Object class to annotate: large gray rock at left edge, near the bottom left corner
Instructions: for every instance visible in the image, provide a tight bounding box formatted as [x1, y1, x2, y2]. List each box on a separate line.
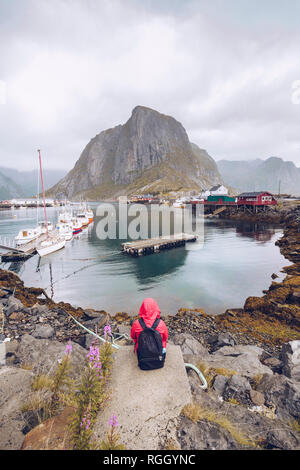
[0, 367, 32, 450]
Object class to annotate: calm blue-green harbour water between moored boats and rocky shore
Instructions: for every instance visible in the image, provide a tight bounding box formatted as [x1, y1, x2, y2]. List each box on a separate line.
[0, 205, 289, 314]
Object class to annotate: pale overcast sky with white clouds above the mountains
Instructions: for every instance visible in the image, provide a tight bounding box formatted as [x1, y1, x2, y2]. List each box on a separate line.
[0, 0, 300, 170]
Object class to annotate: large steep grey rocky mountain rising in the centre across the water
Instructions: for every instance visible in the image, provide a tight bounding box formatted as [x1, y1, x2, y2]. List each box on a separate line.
[47, 106, 222, 199]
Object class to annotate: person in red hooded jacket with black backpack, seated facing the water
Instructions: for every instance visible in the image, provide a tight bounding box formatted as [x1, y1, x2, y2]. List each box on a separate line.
[131, 298, 168, 370]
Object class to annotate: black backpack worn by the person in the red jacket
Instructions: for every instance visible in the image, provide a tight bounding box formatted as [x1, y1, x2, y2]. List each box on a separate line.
[137, 318, 165, 370]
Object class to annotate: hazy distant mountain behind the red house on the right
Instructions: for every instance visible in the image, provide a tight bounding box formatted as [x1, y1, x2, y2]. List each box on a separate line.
[217, 157, 300, 196]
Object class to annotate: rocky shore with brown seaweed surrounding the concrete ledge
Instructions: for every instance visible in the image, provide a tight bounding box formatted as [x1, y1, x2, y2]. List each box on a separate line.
[0, 206, 300, 449]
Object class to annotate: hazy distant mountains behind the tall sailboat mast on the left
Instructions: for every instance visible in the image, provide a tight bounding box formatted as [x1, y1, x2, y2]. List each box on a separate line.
[0, 167, 66, 200]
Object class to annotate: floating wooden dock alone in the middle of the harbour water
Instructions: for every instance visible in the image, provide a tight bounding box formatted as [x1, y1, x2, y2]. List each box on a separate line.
[121, 233, 197, 256]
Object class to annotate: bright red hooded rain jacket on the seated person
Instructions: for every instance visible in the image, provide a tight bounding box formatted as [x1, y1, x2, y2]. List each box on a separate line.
[130, 298, 168, 352]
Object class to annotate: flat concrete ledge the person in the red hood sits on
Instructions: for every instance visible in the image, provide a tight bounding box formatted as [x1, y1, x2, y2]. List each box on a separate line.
[95, 345, 192, 450]
